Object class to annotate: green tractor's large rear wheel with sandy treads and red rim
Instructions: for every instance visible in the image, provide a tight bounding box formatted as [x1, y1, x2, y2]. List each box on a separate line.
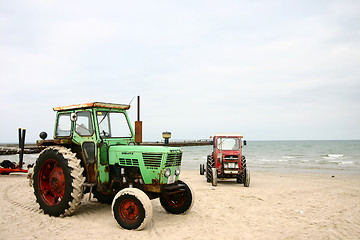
[33, 146, 85, 216]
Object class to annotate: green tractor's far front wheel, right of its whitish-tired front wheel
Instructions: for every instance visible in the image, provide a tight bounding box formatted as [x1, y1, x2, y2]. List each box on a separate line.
[160, 180, 195, 214]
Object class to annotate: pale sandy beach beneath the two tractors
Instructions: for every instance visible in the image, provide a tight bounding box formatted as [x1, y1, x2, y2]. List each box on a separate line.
[0, 170, 360, 240]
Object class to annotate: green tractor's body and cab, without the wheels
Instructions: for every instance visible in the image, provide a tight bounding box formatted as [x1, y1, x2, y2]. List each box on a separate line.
[38, 103, 182, 192]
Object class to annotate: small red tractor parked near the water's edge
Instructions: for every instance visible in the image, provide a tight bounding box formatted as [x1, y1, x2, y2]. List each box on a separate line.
[200, 133, 250, 187]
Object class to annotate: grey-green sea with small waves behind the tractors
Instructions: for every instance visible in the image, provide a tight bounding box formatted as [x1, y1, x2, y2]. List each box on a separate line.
[0, 140, 360, 175]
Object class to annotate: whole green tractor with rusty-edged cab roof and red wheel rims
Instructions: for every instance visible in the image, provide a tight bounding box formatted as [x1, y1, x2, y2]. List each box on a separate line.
[33, 99, 194, 230]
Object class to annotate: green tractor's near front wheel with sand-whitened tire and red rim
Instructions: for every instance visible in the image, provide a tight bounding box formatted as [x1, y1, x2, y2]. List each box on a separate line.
[111, 188, 153, 230]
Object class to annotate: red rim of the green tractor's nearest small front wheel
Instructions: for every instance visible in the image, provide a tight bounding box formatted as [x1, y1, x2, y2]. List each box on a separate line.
[118, 199, 140, 224]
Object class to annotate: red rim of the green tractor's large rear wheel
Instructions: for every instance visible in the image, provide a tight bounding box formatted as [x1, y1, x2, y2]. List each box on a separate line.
[38, 159, 65, 206]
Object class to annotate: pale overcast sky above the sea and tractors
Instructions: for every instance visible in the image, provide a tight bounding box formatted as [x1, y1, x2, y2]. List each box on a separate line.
[0, 0, 360, 143]
